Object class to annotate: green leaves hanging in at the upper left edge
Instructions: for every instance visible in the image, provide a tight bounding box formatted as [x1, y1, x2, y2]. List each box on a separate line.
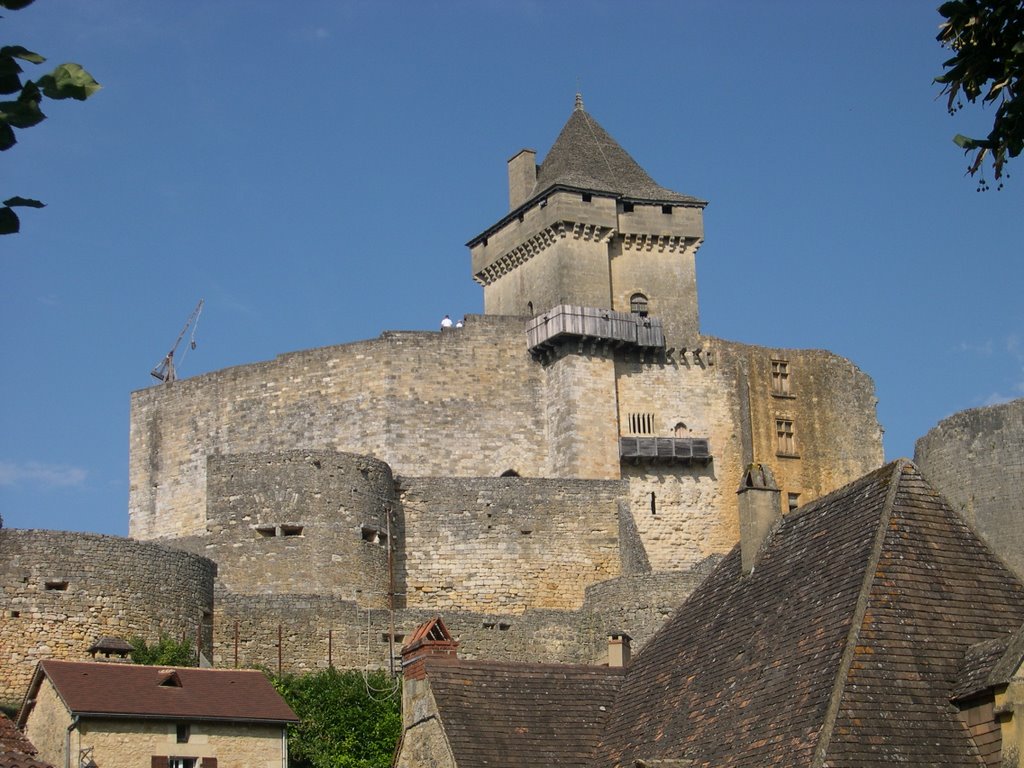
[0, 0, 99, 234]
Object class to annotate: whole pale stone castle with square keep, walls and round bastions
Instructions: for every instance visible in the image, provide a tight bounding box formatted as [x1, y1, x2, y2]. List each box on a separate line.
[0, 98, 883, 708]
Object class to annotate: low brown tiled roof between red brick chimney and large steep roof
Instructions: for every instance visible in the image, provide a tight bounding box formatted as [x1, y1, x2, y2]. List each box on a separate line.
[426, 659, 624, 768]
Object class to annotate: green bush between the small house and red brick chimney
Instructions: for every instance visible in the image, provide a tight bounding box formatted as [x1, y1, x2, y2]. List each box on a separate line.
[272, 669, 401, 768]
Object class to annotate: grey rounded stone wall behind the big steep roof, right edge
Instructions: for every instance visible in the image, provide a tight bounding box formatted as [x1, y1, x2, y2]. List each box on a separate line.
[913, 398, 1024, 578]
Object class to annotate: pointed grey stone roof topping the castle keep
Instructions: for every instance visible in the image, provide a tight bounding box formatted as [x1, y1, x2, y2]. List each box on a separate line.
[530, 96, 705, 205]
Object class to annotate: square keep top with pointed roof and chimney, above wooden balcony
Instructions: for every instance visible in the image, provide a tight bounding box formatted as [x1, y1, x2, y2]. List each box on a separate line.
[467, 95, 707, 347]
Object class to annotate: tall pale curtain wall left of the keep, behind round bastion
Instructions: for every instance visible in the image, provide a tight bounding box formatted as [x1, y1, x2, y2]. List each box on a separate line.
[129, 315, 548, 539]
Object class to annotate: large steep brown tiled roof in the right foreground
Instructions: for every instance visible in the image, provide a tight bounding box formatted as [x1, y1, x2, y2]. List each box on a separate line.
[596, 461, 1024, 768]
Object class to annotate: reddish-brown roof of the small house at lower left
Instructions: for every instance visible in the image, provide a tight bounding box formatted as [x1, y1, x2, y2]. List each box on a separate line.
[20, 659, 298, 724]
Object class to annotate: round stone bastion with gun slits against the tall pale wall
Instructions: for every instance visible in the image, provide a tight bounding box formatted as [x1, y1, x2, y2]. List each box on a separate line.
[184, 451, 398, 608]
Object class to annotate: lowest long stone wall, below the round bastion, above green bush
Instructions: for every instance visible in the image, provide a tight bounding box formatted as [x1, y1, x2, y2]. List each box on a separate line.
[215, 573, 711, 673]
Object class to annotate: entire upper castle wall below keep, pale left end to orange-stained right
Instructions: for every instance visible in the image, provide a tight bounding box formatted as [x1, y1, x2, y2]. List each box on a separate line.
[129, 315, 882, 573]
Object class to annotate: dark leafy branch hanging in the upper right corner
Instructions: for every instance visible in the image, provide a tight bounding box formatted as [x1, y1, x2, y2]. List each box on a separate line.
[935, 0, 1024, 189]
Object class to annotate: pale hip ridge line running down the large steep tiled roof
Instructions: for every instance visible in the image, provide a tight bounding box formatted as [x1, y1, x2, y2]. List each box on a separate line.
[811, 459, 916, 768]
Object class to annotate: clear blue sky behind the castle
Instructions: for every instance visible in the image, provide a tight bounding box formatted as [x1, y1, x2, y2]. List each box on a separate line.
[0, 0, 1024, 534]
